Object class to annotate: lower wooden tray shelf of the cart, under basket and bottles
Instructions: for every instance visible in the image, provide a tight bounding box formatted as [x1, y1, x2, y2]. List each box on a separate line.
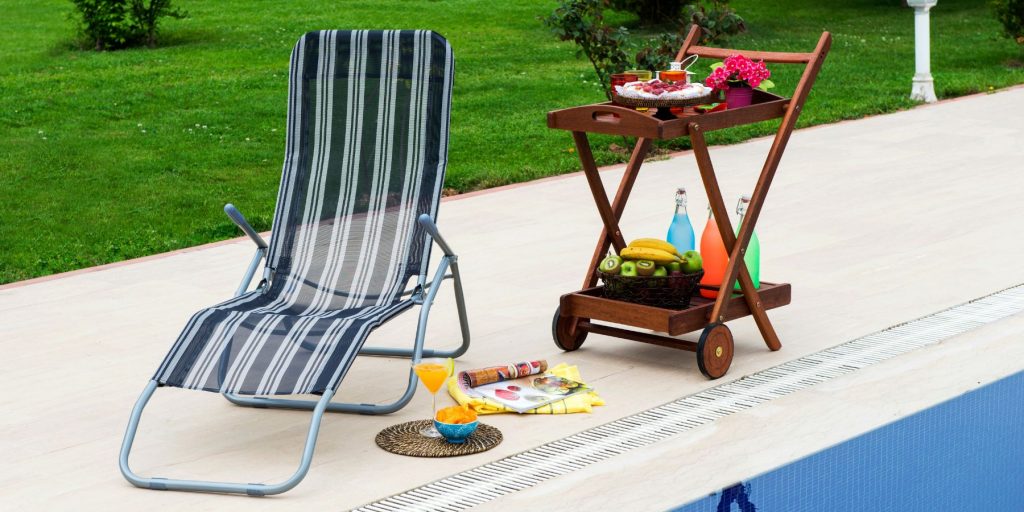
[559, 283, 791, 335]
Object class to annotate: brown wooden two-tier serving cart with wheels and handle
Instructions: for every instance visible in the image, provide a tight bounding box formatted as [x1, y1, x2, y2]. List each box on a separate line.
[548, 27, 831, 379]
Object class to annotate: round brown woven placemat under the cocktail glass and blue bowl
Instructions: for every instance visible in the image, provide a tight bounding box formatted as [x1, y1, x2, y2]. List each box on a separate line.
[376, 420, 502, 457]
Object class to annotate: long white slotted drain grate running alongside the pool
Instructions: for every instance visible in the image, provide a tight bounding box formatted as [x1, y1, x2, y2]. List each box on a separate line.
[356, 285, 1024, 511]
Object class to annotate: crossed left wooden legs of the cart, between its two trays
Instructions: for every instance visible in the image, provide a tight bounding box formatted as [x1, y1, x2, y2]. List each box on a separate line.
[572, 131, 651, 289]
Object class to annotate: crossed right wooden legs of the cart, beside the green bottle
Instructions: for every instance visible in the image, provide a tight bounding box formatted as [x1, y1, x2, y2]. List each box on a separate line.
[688, 123, 782, 350]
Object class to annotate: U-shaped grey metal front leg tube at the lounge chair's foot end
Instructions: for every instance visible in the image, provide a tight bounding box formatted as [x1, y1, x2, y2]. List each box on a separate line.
[119, 380, 334, 496]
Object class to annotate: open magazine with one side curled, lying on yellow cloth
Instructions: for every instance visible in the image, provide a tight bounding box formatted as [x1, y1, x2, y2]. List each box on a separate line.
[458, 361, 591, 413]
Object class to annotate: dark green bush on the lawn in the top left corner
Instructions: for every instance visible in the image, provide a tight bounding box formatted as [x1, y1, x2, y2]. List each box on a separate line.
[71, 0, 187, 51]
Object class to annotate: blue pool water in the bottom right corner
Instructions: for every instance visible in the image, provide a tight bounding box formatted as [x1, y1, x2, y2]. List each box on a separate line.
[675, 372, 1024, 512]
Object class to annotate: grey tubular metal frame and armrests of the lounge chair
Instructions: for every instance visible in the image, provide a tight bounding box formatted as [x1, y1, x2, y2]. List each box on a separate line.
[119, 204, 470, 496]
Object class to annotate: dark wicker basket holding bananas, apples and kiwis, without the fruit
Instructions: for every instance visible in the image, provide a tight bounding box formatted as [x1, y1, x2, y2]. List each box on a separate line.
[597, 270, 703, 309]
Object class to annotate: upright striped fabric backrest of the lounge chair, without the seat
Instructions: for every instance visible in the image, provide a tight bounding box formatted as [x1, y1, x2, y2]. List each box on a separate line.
[267, 31, 454, 313]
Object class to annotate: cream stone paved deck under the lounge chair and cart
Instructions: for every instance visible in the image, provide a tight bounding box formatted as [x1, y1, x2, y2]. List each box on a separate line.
[6, 88, 1024, 511]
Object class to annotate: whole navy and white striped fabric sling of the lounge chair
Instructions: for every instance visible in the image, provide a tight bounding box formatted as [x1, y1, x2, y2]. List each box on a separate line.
[155, 31, 454, 394]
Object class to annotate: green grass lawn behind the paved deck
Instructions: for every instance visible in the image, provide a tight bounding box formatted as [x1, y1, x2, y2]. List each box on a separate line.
[0, 0, 1024, 283]
